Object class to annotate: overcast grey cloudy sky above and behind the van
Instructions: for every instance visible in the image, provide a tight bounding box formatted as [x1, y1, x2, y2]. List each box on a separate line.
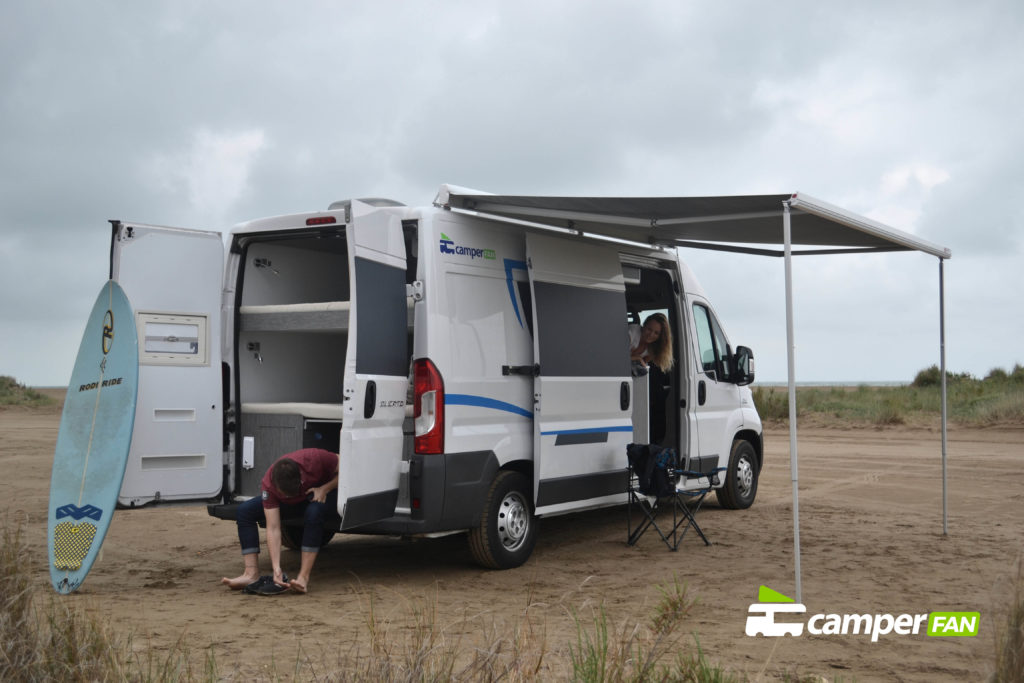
[0, 0, 1024, 385]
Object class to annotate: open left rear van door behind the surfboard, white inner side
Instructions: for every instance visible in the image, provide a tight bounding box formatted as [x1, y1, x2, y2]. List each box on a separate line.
[111, 221, 224, 506]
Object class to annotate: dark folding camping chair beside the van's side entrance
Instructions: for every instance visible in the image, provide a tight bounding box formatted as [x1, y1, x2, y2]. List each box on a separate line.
[626, 443, 725, 551]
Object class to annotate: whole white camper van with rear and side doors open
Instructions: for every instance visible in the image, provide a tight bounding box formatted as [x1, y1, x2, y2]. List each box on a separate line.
[111, 186, 764, 568]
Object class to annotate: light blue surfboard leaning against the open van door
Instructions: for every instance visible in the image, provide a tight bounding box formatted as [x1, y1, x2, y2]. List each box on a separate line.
[46, 280, 138, 594]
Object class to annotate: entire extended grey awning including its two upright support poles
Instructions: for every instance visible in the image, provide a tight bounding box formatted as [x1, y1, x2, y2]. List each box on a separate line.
[434, 185, 952, 602]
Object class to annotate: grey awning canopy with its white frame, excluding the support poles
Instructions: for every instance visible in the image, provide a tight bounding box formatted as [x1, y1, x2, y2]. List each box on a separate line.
[435, 185, 950, 258]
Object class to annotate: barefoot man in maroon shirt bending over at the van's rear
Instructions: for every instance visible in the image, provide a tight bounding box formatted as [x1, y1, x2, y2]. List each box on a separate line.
[220, 449, 338, 595]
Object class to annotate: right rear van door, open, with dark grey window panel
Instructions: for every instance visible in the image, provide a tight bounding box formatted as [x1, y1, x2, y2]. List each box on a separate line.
[338, 201, 409, 529]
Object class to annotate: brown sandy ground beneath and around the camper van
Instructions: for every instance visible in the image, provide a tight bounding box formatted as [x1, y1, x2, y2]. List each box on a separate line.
[0, 397, 1024, 681]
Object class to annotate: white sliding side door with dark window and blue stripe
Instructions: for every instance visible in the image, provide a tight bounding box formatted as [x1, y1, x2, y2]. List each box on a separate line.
[526, 234, 633, 514]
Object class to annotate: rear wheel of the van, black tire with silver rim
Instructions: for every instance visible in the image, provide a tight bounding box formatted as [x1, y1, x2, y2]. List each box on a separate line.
[469, 470, 537, 569]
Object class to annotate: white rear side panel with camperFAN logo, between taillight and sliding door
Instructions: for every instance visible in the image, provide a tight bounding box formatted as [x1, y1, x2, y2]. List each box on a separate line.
[428, 211, 534, 464]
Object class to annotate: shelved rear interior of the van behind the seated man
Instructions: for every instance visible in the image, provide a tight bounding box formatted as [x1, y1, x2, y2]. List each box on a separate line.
[236, 228, 413, 506]
